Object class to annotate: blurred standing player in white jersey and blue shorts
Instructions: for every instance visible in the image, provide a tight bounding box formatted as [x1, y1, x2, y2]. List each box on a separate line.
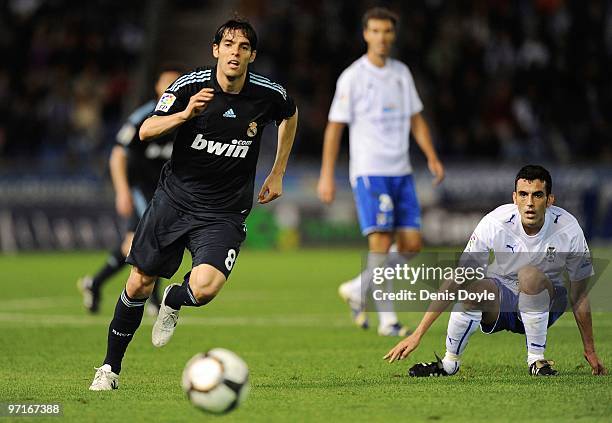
[317, 7, 444, 336]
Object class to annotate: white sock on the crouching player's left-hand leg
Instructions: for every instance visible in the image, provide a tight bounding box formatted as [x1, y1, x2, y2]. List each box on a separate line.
[442, 303, 482, 375]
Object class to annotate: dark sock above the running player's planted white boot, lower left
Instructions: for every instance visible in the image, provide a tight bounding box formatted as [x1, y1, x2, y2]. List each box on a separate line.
[104, 289, 147, 374]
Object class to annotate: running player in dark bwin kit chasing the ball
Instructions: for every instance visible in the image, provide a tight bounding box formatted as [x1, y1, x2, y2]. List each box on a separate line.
[89, 19, 297, 391]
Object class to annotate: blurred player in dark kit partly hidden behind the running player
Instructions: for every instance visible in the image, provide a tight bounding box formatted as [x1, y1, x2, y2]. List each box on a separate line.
[77, 64, 184, 315]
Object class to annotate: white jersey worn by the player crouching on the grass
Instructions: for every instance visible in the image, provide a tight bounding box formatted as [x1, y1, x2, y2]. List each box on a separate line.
[462, 204, 594, 292]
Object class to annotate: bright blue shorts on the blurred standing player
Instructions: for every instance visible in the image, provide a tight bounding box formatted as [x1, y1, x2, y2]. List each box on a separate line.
[353, 175, 421, 235]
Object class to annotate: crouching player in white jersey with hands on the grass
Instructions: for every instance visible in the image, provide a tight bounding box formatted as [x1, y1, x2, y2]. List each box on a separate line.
[383, 165, 607, 377]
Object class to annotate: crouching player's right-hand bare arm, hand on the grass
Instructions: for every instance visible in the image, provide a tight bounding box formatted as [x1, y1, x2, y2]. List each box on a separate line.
[570, 280, 608, 375]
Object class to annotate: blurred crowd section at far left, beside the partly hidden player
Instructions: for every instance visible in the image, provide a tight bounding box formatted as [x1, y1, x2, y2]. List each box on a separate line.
[0, 0, 143, 168]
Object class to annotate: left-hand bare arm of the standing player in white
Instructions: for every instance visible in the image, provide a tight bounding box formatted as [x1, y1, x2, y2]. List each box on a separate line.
[317, 122, 346, 204]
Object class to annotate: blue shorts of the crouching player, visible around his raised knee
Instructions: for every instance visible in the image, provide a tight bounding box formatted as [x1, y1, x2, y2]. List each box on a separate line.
[480, 278, 567, 333]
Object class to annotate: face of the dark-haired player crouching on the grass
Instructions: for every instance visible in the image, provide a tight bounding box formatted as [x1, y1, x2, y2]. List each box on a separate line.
[512, 179, 554, 235]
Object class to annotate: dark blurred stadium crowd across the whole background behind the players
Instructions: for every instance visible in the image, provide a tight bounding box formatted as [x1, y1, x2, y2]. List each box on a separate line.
[0, 0, 612, 172]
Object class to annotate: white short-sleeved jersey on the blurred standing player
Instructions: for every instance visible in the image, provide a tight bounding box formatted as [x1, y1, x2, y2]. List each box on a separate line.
[328, 55, 423, 181]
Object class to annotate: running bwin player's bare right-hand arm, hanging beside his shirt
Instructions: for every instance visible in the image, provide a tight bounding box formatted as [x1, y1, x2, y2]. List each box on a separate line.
[257, 109, 298, 204]
